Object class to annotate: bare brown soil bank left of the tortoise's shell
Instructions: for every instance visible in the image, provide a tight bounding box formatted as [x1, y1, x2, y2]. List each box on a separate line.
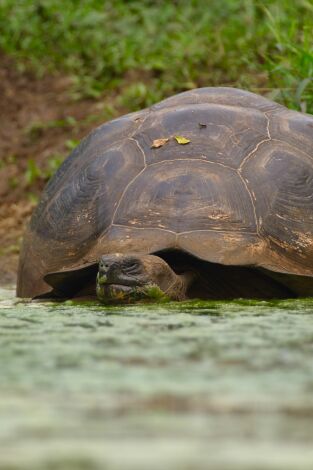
[0, 55, 120, 285]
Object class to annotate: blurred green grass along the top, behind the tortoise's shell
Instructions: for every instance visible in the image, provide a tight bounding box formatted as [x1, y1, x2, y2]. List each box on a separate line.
[0, 0, 313, 113]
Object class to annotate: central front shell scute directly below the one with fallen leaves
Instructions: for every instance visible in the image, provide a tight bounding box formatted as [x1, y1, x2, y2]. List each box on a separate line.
[113, 160, 256, 233]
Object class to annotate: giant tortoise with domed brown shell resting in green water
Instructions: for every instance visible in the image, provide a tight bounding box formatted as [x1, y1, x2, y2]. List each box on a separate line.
[17, 87, 313, 302]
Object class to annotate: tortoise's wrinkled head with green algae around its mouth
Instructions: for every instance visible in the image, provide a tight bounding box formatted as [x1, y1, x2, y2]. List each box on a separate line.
[97, 253, 186, 303]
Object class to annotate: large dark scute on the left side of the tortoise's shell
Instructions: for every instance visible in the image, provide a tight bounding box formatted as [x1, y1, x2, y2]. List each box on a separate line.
[31, 140, 144, 245]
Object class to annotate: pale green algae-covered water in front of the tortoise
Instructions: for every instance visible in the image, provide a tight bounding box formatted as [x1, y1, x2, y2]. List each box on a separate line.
[0, 289, 313, 470]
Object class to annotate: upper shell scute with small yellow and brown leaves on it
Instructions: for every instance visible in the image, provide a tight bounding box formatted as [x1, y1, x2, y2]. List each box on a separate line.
[134, 104, 268, 168]
